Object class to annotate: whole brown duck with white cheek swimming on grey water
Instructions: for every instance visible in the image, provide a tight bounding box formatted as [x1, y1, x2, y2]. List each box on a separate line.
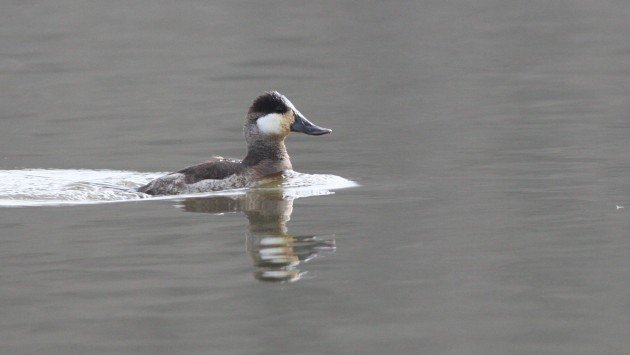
[138, 91, 332, 195]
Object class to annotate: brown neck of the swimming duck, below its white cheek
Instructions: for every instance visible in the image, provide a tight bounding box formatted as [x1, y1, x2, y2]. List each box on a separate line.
[243, 139, 292, 175]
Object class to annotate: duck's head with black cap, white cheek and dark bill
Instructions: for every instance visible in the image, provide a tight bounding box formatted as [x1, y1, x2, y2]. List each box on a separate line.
[245, 91, 332, 141]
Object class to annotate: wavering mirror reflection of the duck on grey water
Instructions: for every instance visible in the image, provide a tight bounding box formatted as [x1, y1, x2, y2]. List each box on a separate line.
[182, 189, 335, 282]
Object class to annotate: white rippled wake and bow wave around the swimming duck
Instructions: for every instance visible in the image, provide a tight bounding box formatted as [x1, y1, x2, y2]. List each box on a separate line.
[0, 169, 357, 207]
